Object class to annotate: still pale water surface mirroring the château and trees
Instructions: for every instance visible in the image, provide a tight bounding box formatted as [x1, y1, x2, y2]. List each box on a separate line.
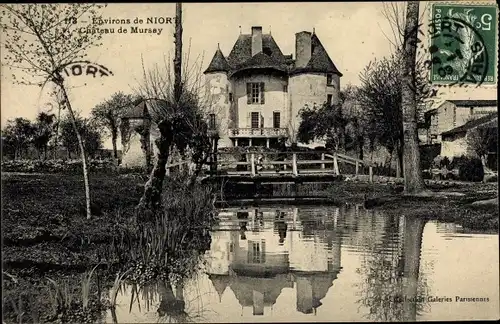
[107, 205, 500, 323]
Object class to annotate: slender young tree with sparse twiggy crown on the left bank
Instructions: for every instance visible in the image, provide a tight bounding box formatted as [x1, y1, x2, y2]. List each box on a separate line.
[0, 3, 103, 218]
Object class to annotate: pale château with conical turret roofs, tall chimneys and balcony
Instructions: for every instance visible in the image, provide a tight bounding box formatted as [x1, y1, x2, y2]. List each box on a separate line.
[204, 26, 342, 147]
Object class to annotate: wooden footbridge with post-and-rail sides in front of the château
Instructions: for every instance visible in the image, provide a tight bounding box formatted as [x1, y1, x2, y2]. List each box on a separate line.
[167, 151, 373, 182]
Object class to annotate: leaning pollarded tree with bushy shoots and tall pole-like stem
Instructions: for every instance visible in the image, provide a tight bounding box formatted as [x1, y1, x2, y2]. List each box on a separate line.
[136, 3, 216, 218]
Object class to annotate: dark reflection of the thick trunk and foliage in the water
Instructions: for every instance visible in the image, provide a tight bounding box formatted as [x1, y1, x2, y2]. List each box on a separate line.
[357, 210, 430, 321]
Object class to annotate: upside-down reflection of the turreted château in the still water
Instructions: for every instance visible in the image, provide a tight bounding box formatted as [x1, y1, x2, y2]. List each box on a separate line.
[207, 207, 342, 315]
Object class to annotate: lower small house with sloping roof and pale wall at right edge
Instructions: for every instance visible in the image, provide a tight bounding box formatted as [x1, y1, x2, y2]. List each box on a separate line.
[441, 112, 498, 167]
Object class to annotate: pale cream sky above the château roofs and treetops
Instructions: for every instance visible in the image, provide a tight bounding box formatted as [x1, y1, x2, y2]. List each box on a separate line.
[1, 2, 496, 147]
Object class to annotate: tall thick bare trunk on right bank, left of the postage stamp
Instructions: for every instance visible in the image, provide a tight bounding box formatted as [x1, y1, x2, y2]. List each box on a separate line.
[401, 1, 424, 194]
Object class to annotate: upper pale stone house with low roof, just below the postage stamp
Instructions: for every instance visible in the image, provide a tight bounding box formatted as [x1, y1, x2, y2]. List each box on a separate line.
[424, 100, 498, 144]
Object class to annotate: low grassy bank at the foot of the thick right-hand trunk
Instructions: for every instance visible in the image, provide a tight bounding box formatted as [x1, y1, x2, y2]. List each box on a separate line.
[329, 182, 498, 233]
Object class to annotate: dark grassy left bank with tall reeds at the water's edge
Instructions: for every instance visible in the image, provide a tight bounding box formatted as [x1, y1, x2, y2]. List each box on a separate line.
[2, 174, 215, 323]
